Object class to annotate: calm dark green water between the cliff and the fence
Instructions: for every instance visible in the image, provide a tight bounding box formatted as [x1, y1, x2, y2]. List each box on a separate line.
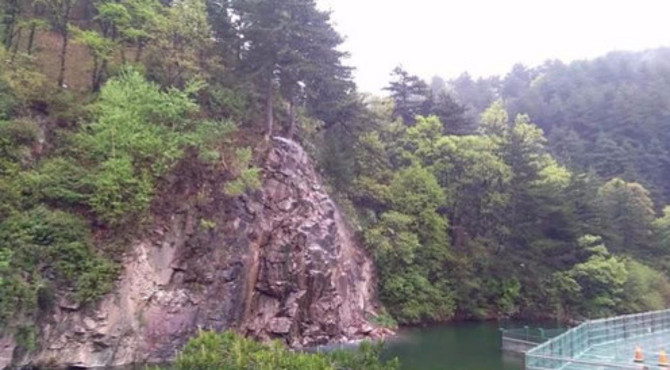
[383, 323, 523, 370]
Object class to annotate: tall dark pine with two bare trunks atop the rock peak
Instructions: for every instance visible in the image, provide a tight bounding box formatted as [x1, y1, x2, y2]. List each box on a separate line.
[231, 0, 352, 139]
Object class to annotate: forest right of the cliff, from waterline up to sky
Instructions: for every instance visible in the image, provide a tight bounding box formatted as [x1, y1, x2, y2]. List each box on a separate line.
[325, 49, 670, 323]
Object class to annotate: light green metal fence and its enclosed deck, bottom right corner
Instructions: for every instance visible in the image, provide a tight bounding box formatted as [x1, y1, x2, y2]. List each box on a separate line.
[526, 310, 670, 370]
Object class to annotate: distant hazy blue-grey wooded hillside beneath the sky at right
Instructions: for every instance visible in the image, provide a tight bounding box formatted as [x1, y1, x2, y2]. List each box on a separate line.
[431, 49, 670, 202]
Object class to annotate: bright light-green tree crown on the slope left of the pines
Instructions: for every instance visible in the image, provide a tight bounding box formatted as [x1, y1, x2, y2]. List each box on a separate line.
[77, 70, 198, 169]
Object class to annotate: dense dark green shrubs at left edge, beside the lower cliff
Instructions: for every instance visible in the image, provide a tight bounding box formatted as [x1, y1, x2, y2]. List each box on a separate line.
[0, 206, 115, 323]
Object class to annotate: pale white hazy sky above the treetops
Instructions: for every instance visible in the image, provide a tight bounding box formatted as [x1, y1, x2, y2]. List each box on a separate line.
[317, 0, 670, 92]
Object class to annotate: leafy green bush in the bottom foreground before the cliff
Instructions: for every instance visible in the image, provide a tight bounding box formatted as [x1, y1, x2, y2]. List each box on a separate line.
[175, 331, 399, 370]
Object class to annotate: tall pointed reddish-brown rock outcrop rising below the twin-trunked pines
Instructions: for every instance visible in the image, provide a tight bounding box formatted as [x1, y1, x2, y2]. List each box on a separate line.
[246, 139, 372, 347]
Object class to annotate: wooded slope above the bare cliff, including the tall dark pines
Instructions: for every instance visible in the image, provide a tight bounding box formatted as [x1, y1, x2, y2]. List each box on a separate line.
[0, 0, 359, 360]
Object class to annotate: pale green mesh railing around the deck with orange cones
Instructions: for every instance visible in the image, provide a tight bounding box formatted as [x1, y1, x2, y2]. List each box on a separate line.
[526, 310, 670, 370]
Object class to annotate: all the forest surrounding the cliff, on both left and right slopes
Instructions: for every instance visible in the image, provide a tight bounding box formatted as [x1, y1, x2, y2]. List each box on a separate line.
[0, 0, 670, 368]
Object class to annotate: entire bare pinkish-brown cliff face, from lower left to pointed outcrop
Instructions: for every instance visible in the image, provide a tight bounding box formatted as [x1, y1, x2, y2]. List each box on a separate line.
[7, 138, 380, 367]
